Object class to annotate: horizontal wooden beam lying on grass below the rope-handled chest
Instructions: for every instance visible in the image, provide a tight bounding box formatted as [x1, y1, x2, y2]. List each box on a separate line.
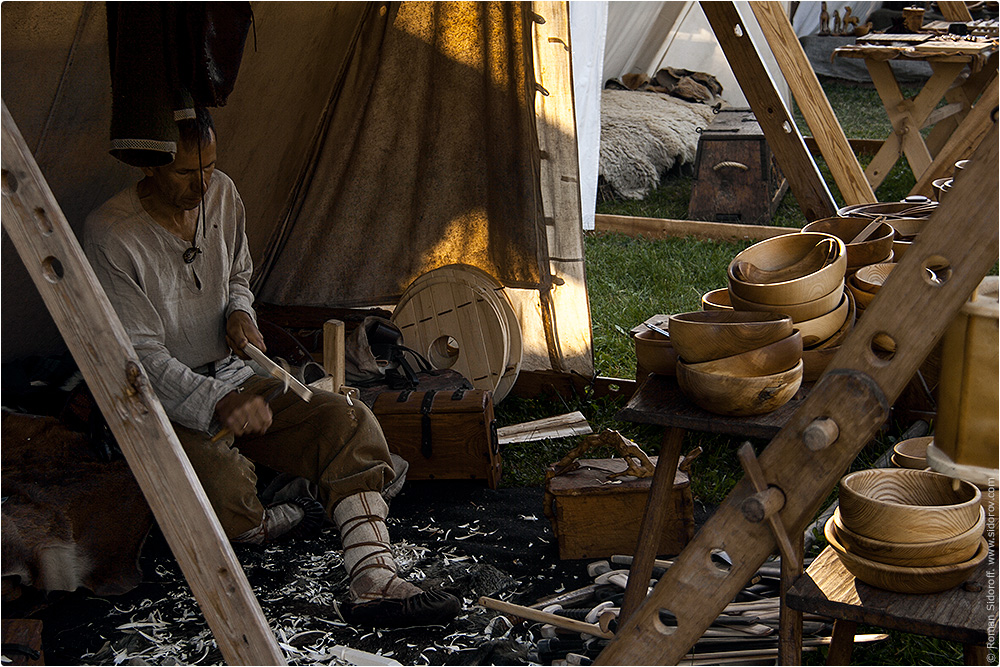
[594, 213, 798, 241]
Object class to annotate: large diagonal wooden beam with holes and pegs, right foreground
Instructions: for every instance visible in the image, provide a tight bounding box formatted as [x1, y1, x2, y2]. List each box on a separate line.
[596, 120, 1000, 665]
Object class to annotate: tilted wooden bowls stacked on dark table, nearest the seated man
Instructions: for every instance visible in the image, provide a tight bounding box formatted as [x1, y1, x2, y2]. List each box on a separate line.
[669, 310, 803, 416]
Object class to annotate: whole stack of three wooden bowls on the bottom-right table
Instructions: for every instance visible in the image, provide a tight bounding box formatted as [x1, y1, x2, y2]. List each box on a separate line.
[825, 468, 989, 594]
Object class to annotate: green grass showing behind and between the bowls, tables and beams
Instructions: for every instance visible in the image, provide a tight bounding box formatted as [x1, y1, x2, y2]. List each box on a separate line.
[497, 83, 976, 665]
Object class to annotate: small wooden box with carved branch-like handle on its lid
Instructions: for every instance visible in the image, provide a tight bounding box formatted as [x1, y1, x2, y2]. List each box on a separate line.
[545, 456, 694, 559]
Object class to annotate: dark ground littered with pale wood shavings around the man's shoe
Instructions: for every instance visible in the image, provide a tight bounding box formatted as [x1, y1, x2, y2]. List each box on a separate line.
[17, 481, 720, 665]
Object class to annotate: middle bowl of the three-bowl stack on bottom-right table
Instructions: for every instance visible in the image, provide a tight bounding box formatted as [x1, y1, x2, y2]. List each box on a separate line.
[830, 509, 986, 567]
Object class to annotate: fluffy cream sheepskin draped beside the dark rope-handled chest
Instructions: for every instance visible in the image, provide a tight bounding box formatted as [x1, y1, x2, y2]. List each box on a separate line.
[598, 89, 714, 199]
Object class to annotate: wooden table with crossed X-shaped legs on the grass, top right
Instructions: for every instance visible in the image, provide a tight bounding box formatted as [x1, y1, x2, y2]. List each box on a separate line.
[833, 33, 997, 194]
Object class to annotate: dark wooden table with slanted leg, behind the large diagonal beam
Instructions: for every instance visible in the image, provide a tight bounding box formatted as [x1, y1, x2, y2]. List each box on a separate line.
[617, 374, 808, 636]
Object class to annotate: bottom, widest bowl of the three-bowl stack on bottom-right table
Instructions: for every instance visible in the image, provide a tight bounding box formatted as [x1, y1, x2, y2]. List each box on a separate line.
[824, 521, 989, 595]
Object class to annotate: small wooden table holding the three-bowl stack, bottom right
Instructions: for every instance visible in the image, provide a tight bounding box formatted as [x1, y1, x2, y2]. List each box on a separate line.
[785, 547, 996, 665]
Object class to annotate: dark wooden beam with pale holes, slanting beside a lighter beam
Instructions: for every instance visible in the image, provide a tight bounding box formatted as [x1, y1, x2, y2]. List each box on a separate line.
[701, 2, 837, 221]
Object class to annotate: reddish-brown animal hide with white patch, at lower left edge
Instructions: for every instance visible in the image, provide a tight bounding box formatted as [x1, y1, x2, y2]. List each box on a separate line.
[0, 412, 153, 598]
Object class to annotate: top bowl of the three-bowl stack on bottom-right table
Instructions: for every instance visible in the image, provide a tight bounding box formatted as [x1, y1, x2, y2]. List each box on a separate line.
[839, 468, 982, 542]
